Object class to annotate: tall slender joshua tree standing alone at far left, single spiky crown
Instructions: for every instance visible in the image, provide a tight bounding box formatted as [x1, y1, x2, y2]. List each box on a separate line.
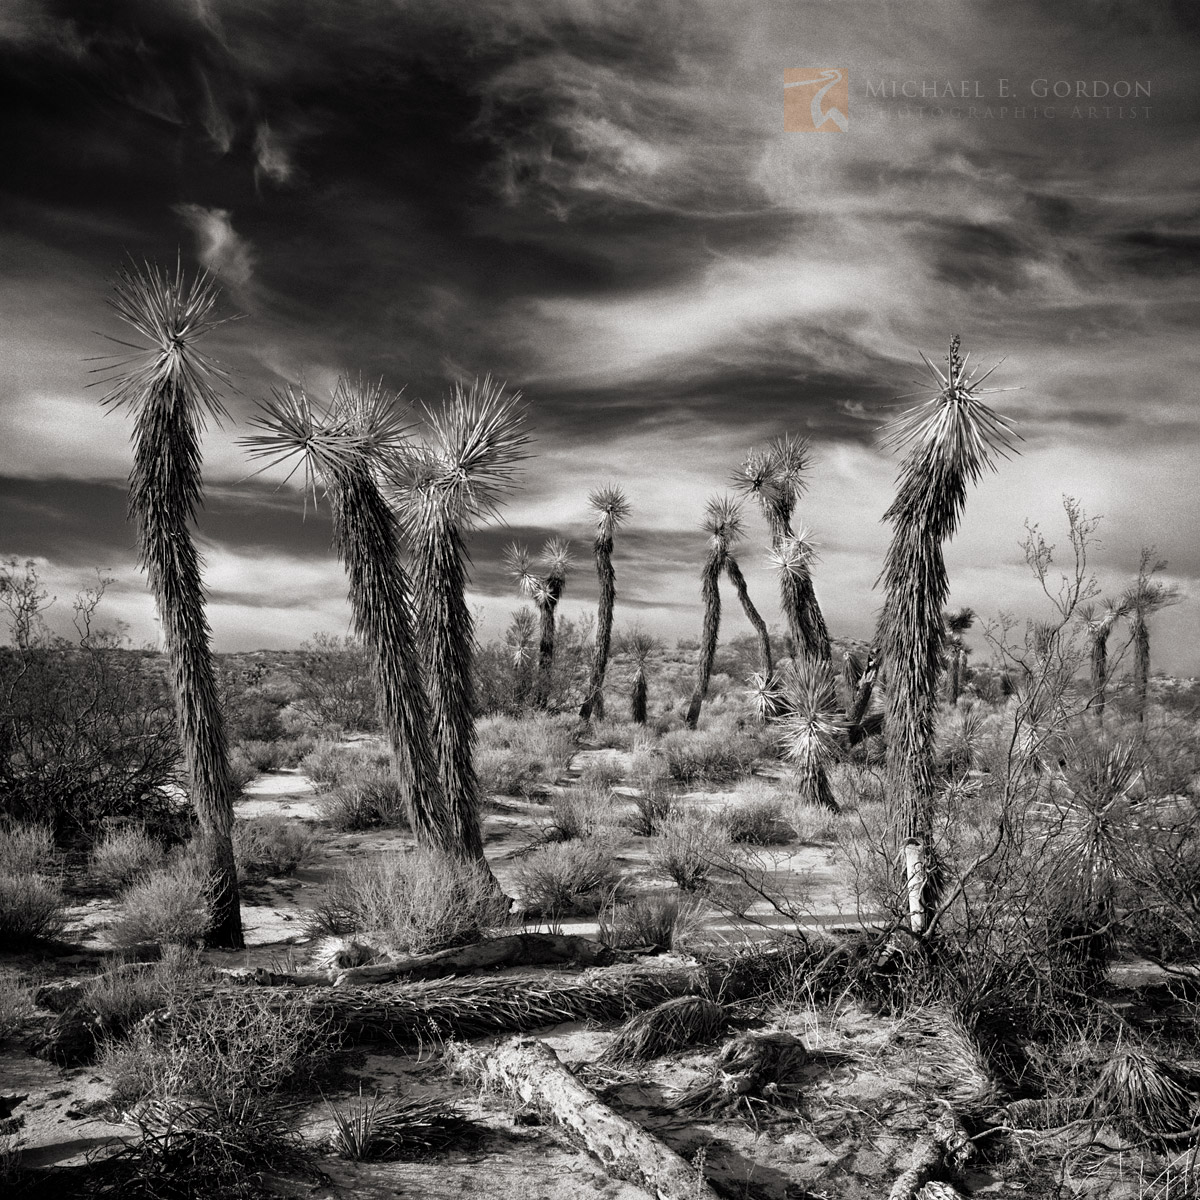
[96, 264, 244, 949]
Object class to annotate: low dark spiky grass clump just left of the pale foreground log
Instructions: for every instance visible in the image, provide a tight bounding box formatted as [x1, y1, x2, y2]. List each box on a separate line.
[325, 1087, 469, 1162]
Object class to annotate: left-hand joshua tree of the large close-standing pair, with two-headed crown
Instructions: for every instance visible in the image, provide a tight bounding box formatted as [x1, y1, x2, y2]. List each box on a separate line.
[241, 379, 448, 854]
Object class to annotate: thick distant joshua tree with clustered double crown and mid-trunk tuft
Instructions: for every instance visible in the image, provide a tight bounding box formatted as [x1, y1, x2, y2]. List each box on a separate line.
[733, 434, 829, 662]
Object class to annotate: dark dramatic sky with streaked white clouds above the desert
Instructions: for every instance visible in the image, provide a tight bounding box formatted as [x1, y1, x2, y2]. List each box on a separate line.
[0, 0, 1200, 673]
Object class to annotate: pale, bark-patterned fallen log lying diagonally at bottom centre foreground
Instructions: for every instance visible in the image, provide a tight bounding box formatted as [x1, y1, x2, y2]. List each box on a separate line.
[451, 1038, 718, 1200]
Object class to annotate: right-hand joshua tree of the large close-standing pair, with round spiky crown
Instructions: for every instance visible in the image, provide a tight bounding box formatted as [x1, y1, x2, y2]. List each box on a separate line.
[397, 377, 529, 862]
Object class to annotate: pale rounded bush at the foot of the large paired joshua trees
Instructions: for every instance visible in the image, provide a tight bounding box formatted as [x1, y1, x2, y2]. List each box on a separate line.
[311, 848, 506, 954]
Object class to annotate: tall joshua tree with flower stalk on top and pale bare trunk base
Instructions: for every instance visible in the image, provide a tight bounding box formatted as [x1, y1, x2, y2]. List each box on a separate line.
[876, 337, 1012, 932]
